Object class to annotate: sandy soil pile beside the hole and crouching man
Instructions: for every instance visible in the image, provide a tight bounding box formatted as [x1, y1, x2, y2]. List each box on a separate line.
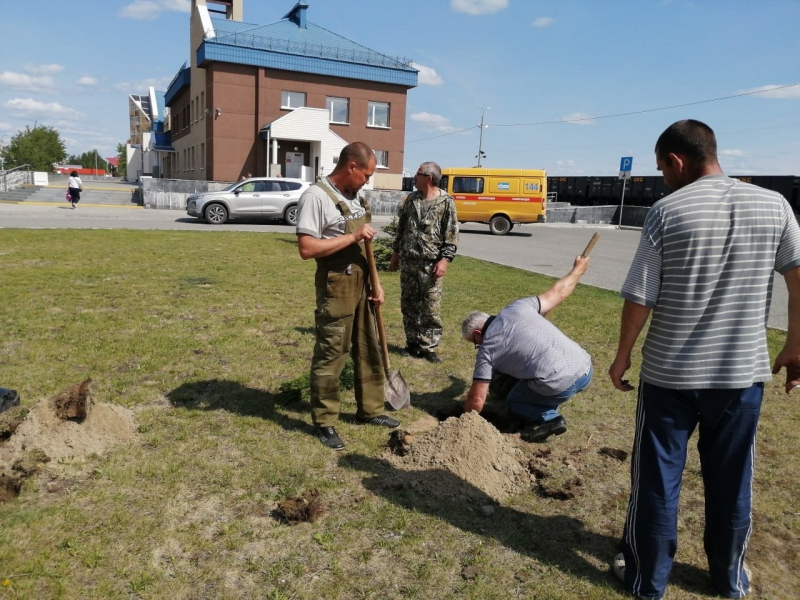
[387, 412, 532, 503]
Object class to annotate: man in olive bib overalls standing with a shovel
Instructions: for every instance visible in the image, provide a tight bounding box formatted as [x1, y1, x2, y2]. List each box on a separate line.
[297, 142, 400, 450]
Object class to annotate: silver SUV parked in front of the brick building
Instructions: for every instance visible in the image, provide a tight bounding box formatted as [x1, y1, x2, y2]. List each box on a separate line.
[186, 177, 309, 225]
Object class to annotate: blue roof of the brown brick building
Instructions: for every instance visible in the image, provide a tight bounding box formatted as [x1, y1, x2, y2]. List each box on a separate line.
[203, 7, 418, 87]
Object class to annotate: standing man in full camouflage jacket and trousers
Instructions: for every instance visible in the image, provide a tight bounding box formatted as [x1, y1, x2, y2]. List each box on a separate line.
[390, 162, 458, 363]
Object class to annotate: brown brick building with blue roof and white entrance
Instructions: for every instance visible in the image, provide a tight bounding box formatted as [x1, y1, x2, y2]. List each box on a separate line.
[163, 0, 417, 189]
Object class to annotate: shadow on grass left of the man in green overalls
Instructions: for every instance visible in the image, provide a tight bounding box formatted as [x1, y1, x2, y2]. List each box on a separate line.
[167, 379, 314, 435]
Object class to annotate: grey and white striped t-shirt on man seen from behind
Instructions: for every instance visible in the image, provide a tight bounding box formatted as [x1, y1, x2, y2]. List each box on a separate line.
[621, 175, 800, 389]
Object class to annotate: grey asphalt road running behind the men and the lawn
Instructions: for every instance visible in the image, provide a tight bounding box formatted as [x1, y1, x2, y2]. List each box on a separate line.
[0, 203, 788, 331]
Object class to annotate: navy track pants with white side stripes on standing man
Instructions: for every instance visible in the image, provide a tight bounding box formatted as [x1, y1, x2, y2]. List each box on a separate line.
[623, 382, 764, 598]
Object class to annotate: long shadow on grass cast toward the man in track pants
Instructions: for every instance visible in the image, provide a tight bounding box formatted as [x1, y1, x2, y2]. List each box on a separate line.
[339, 454, 714, 595]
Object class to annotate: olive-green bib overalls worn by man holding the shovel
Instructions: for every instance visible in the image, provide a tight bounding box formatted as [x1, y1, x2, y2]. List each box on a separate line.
[311, 183, 384, 427]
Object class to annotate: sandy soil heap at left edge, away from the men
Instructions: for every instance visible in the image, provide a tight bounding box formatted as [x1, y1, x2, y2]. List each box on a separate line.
[0, 400, 138, 465]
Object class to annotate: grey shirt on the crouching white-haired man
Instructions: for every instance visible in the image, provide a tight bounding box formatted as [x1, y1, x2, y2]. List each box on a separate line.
[472, 296, 592, 396]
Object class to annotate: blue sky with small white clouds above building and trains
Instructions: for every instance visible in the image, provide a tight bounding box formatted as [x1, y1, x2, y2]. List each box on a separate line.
[0, 0, 800, 175]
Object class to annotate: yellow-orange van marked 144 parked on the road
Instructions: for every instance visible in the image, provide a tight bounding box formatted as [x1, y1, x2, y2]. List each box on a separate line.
[439, 167, 547, 235]
